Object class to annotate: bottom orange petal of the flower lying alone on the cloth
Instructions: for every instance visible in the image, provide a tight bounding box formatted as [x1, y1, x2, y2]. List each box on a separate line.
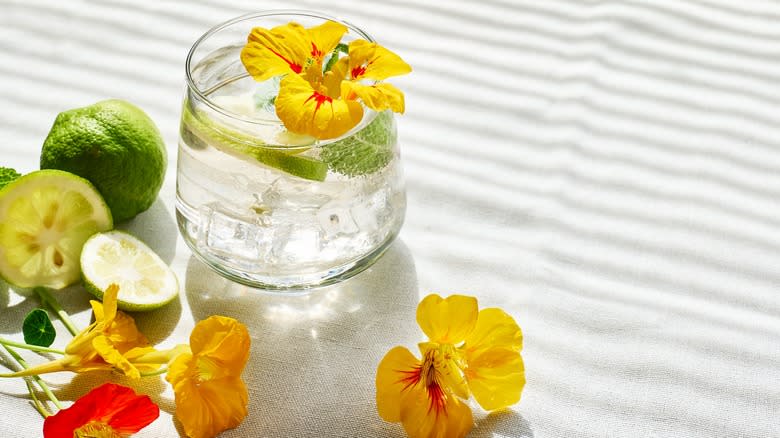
[401, 388, 474, 438]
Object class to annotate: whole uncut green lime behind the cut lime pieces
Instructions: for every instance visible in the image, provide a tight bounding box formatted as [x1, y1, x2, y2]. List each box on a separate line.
[41, 99, 168, 222]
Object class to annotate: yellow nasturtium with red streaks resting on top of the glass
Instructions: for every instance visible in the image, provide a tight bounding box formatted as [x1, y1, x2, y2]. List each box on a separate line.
[241, 21, 412, 139]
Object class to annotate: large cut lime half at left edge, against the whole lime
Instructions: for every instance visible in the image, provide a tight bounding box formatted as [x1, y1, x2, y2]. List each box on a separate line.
[0, 170, 113, 289]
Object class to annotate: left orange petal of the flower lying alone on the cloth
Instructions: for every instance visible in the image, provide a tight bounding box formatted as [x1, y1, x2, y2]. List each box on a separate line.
[376, 347, 420, 423]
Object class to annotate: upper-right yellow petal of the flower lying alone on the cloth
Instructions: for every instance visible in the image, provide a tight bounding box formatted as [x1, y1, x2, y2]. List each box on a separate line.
[463, 307, 523, 351]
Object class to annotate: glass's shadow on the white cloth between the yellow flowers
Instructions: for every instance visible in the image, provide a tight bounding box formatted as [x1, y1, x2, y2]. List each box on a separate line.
[185, 240, 421, 436]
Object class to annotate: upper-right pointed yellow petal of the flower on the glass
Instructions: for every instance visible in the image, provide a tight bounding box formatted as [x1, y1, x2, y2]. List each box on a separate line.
[349, 40, 412, 81]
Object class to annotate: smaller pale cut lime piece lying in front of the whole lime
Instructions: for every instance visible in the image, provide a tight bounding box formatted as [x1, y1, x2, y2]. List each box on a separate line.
[81, 231, 179, 311]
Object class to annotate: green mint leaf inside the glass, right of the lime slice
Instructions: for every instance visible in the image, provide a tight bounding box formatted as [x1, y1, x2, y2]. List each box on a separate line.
[320, 111, 396, 176]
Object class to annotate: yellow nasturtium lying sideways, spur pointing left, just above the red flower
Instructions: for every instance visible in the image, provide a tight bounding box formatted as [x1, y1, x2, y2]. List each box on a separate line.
[3, 284, 159, 379]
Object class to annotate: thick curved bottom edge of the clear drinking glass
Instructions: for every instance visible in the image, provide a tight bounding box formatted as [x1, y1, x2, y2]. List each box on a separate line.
[176, 208, 401, 293]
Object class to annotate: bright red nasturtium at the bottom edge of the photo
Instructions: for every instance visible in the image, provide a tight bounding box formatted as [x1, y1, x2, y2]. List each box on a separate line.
[43, 383, 160, 438]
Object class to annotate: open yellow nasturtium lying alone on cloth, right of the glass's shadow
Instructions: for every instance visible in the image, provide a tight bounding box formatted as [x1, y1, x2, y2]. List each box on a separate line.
[376, 295, 525, 438]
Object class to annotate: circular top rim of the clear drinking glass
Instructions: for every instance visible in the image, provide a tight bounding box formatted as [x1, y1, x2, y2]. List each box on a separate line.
[184, 9, 376, 131]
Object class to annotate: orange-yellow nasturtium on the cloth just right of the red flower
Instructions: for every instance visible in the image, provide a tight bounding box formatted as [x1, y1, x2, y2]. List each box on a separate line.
[165, 316, 250, 438]
